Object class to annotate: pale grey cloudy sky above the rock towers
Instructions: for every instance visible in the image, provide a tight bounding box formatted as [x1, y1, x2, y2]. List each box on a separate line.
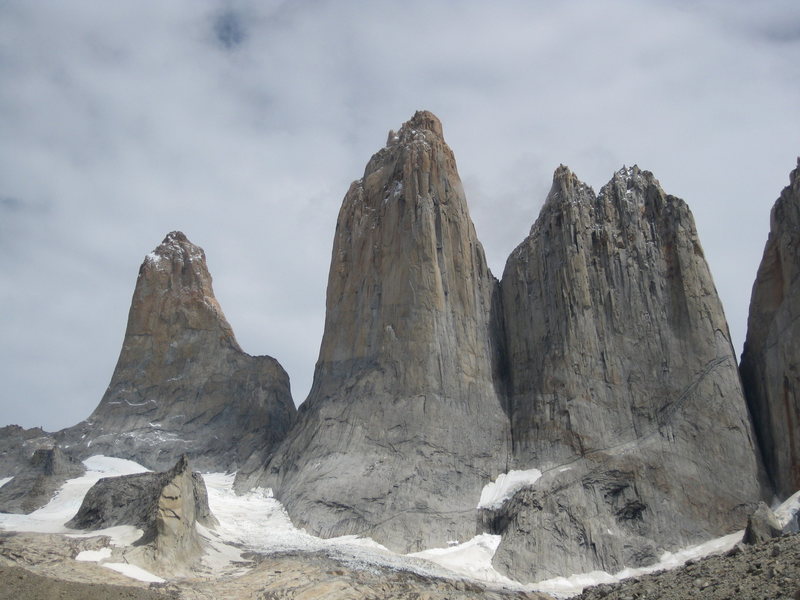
[0, 0, 800, 430]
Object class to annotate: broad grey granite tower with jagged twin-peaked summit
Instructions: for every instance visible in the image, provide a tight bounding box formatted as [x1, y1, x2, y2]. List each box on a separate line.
[482, 167, 761, 581]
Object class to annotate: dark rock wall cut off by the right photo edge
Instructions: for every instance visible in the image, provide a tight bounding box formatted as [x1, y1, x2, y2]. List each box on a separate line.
[741, 159, 800, 498]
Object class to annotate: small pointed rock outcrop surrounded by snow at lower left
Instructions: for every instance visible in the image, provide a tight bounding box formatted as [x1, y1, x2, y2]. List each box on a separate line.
[67, 455, 216, 574]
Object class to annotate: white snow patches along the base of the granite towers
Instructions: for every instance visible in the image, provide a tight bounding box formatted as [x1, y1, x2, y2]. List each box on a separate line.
[0, 456, 800, 598]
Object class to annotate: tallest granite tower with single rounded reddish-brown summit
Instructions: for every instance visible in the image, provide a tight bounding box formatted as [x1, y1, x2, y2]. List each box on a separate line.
[237, 112, 509, 551]
